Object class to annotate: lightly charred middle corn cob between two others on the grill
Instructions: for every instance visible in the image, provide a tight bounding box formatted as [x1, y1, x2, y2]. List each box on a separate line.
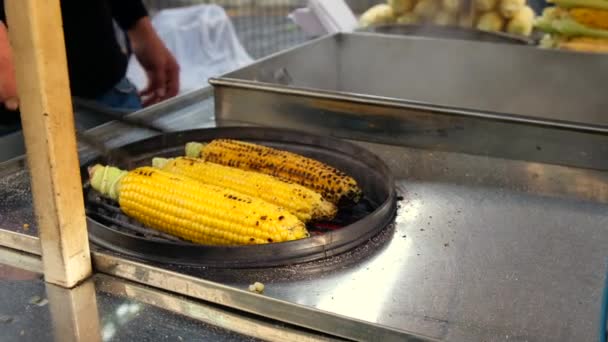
[152, 157, 337, 222]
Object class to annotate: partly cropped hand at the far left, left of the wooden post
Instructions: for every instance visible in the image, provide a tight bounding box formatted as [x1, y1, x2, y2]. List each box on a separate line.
[0, 22, 19, 110]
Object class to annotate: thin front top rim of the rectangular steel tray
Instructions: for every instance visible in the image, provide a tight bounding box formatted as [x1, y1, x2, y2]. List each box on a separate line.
[209, 77, 608, 133]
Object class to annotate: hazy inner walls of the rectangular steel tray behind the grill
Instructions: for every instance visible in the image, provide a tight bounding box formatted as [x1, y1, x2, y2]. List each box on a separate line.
[220, 33, 608, 127]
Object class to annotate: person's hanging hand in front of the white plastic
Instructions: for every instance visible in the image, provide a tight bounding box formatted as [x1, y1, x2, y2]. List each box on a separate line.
[129, 17, 179, 106]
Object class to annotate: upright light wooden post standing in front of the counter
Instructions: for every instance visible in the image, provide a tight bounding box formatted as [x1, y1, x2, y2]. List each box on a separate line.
[5, 0, 92, 288]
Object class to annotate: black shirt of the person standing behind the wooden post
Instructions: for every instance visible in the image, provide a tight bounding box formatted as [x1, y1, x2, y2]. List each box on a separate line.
[0, 0, 148, 98]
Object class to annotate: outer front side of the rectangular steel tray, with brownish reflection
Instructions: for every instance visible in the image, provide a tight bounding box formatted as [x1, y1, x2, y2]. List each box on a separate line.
[215, 81, 608, 170]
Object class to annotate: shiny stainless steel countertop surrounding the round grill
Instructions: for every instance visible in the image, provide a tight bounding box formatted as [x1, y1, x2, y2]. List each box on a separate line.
[0, 86, 608, 341]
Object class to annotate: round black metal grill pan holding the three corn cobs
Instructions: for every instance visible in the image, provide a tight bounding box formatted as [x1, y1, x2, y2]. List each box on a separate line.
[82, 127, 396, 268]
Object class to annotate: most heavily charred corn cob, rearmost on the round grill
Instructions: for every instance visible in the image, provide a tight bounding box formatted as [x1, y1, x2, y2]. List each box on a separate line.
[186, 139, 362, 204]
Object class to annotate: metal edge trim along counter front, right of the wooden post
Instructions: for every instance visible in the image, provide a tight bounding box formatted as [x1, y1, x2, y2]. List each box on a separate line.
[92, 252, 435, 341]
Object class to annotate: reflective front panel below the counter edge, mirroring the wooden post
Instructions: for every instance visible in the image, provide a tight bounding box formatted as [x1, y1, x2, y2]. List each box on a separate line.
[0, 248, 341, 342]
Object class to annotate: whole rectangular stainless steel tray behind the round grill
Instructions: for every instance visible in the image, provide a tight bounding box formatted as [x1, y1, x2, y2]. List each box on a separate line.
[210, 33, 608, 170]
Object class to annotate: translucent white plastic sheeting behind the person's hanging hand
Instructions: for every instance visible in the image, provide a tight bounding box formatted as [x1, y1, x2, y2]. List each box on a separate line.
[127, 5, 253, 93]
